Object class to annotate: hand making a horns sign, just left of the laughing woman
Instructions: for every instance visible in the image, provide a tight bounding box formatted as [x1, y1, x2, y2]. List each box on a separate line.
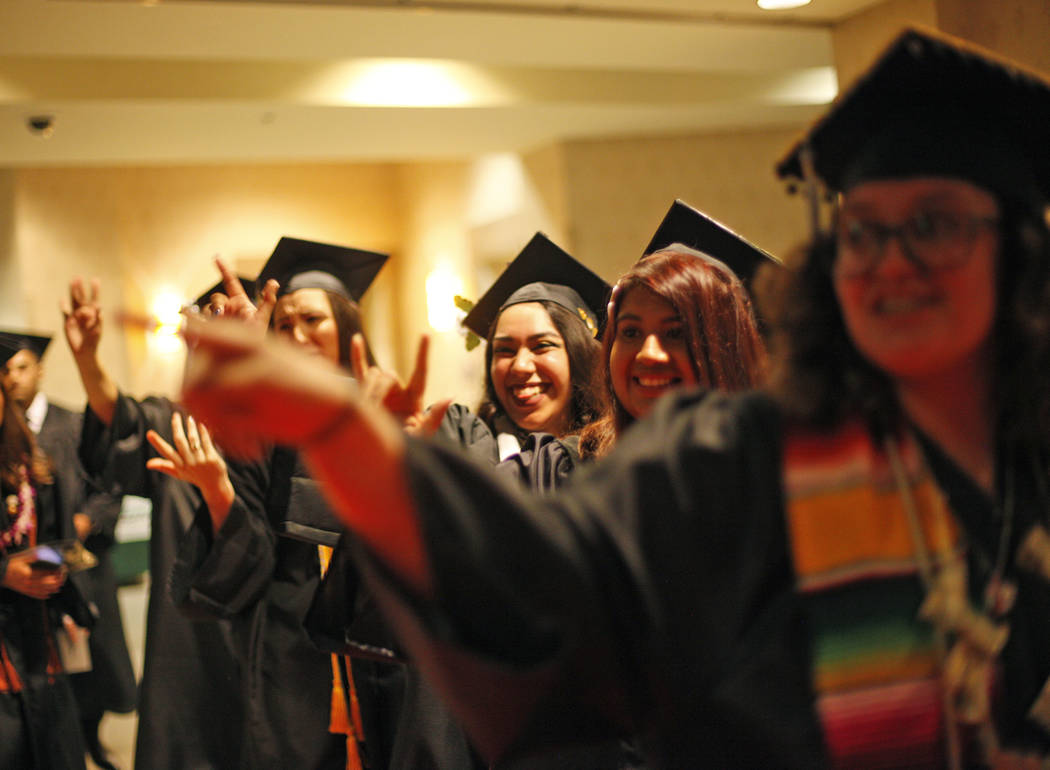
[350, 334, 452, 436]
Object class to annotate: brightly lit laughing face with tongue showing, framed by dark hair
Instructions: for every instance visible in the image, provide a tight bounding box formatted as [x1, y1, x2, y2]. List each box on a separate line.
[489, 303, 572, 435]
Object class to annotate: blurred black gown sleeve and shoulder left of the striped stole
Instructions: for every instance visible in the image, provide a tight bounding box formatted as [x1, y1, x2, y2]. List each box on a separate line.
[378, 393, 825, 768]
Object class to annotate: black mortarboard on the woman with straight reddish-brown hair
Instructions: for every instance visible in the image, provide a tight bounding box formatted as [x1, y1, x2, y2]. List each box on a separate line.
[645, 201, 780, 284]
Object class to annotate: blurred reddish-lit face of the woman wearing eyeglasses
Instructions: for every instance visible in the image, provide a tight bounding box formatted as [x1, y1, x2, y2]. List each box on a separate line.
[833, 179, 999, 380]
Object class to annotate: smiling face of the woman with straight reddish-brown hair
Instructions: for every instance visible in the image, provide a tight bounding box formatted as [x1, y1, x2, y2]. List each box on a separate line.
[609, 287, 697, 418]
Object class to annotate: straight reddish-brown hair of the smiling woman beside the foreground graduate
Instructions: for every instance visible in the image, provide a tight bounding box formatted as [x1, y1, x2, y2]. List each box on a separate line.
[580, 244, 767, 457]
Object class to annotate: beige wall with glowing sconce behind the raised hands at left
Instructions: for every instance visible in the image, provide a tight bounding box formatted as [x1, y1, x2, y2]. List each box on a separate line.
[9, 165, 400, 403]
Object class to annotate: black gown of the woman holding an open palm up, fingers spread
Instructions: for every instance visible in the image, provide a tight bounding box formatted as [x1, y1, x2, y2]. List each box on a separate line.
[165, 449, 347, 770]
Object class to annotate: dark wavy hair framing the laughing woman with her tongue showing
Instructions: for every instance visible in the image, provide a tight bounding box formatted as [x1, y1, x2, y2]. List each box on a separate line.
[478, 299, 608, 436]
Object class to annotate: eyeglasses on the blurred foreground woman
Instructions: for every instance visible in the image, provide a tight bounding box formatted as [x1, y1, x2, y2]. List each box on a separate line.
[834, 211, 999, 278]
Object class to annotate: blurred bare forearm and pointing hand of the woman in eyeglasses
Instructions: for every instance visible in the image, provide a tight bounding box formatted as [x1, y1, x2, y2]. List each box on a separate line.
[183, 319, 432, 596]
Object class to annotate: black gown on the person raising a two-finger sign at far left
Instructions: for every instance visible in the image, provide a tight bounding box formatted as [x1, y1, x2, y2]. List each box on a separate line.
[80, 394, 244, 770]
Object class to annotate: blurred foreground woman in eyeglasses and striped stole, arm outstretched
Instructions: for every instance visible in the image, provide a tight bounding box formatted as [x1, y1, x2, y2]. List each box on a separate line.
[186, 30, 1050, 768]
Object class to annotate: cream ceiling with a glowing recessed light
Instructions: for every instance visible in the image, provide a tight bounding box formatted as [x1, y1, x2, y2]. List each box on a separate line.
[0, 0, 875, 166]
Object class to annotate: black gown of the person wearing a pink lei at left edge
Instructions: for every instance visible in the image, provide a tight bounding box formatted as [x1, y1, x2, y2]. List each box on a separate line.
[0, 476, 92, 770]
